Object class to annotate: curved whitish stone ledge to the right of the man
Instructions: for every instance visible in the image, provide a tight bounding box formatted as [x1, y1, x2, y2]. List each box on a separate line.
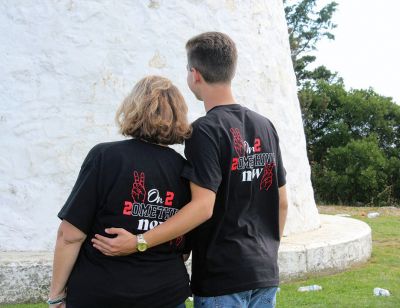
[279, 215, 372, 281]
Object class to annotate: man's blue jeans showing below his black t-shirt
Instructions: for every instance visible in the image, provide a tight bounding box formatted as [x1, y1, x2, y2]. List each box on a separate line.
[194, 287, 278, 308]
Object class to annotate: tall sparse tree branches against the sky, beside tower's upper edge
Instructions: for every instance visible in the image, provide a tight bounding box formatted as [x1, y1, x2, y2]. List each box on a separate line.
[283, 0, 337, 86]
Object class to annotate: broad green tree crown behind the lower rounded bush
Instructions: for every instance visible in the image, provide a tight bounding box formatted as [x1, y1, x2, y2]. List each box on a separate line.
[298, 81, 400, 163]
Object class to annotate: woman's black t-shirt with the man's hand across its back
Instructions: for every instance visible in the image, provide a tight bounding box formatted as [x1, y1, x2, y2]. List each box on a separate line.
[58, 139, 191, 308]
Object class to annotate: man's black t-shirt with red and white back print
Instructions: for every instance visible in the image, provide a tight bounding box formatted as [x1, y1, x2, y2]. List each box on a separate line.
[182, 104, 286, 296]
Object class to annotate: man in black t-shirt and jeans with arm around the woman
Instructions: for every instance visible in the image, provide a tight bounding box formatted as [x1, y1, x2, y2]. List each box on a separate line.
[93, 32, 287, 307]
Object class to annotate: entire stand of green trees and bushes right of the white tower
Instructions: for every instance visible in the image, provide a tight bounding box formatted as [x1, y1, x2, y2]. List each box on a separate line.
[283, 0, 400, 205]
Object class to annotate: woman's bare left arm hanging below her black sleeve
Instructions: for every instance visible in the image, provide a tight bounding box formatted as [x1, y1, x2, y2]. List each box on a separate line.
[49, 220, 86, 300]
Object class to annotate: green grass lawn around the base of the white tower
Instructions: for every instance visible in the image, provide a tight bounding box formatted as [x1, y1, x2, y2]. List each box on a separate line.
[0, 206, 400, 308]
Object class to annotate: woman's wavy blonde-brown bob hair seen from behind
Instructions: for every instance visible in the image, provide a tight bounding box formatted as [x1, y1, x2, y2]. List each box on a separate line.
[116, 76, 191, 145]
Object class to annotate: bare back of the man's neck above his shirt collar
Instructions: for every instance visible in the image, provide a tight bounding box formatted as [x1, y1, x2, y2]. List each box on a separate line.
[202, 84, 236, 111]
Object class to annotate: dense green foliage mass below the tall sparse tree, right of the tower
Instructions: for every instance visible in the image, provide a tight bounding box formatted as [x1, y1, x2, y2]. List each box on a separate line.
[299, 81, 400, 205]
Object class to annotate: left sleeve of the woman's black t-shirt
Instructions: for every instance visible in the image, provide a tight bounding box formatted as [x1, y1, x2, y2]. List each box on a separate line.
[58, 150, 98, 234]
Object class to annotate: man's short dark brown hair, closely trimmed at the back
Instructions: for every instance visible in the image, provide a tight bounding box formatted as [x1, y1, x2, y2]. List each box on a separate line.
[186, 32, 237, 83]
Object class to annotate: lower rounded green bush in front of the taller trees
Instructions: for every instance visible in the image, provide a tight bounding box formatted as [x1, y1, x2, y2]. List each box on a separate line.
[313, 137, 390, 205]
